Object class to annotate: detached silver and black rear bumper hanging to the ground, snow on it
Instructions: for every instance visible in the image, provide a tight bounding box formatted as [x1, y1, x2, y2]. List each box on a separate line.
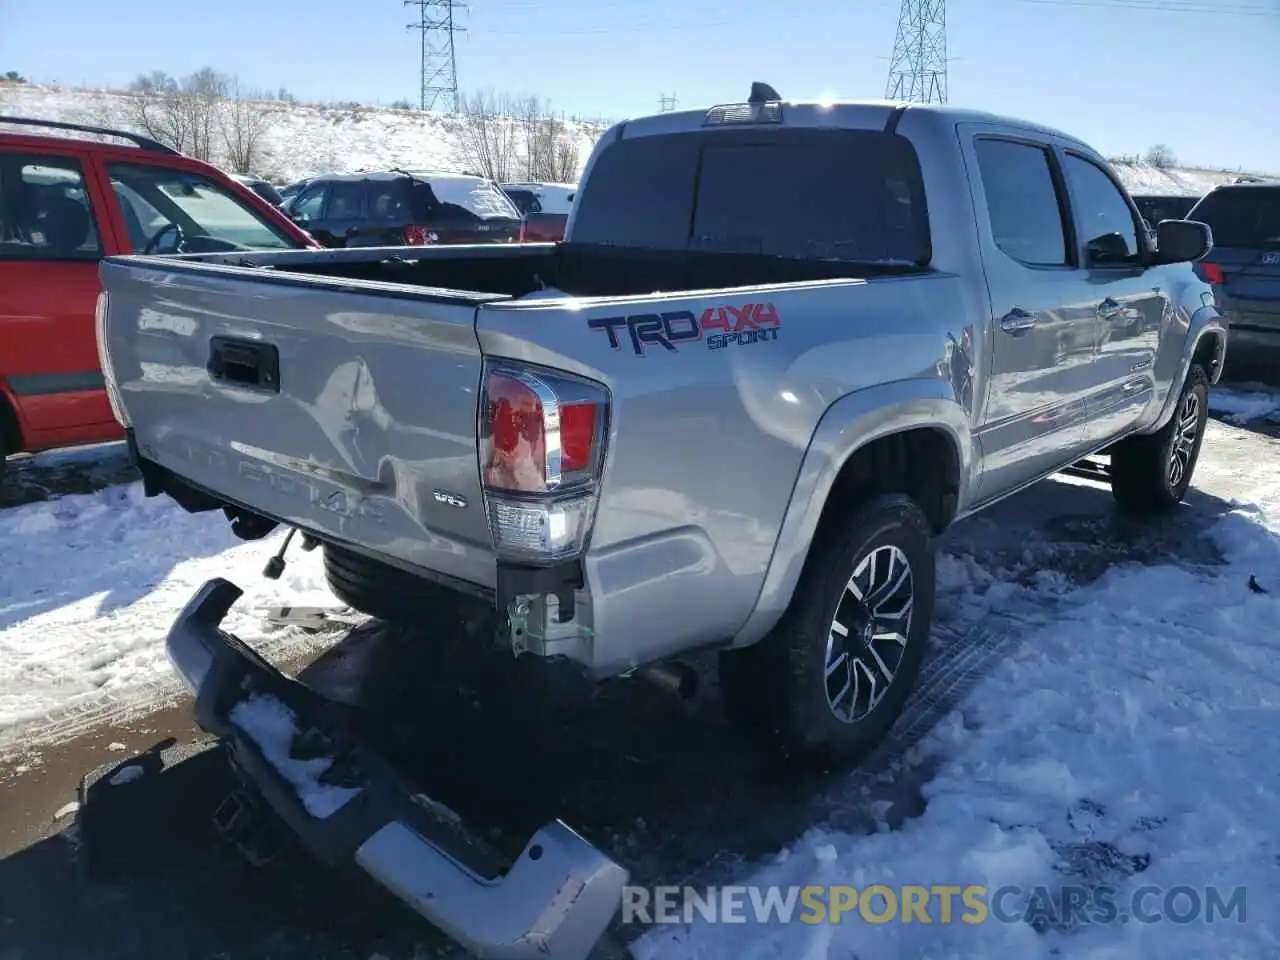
[168, 580, 627, 960]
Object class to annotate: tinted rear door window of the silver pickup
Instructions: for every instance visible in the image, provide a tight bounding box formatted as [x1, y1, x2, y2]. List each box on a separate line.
[974, 138, 1069, 266]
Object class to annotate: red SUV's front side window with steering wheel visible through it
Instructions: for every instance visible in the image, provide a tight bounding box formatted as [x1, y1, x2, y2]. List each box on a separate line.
[106, 164, 302, 253]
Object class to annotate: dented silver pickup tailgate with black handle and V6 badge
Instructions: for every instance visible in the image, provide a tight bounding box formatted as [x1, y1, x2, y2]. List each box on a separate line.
[102, 259, 494, 599]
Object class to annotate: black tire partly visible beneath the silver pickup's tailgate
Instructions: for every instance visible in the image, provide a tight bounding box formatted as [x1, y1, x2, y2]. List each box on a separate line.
[323, 544, 492, 627]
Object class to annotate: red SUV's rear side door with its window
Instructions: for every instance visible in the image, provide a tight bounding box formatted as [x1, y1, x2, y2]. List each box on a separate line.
[0, 143, 122, 451]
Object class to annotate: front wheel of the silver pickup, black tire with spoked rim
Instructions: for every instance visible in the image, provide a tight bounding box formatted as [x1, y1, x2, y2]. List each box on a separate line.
[1111, 365, 1208, 515]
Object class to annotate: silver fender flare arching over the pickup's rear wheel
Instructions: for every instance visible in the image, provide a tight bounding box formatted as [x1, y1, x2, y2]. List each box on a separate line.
[732, 379, 977, 648]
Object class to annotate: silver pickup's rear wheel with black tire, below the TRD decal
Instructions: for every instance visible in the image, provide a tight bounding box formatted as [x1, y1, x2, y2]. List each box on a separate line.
[719, 494, 936, 767]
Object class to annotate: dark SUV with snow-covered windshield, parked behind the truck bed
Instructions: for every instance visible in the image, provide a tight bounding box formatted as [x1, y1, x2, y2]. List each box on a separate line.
[284, 170, 521, 247]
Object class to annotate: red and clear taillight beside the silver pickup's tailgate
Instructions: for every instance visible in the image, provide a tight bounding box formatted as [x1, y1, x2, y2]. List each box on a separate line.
[480, 364, 609, 563]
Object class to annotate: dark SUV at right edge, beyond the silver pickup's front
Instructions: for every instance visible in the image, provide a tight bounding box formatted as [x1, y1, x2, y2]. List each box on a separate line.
[1187, 182, 1280, 371]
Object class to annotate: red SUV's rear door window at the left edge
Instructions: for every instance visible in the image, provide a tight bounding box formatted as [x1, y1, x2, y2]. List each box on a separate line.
[0, 154, 102, 260]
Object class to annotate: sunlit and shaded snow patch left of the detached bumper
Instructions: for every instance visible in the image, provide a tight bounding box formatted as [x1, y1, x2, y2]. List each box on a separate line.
[0, 484, 340, 754]
